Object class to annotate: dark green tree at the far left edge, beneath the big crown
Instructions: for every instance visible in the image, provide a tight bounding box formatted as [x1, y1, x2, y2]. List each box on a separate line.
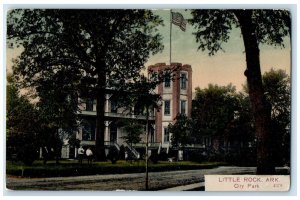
[6, 75, 39, 165]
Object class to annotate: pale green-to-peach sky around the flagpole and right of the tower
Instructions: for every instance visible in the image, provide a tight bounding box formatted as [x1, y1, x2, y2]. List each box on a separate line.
[146, 9, 291, 91]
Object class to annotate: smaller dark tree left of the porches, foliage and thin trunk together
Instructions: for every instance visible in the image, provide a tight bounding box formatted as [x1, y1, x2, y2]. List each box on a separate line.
[36, 71, 80, 163]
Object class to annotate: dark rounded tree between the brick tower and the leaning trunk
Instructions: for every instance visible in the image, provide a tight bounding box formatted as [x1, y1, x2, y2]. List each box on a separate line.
[192, 84, 256, 166]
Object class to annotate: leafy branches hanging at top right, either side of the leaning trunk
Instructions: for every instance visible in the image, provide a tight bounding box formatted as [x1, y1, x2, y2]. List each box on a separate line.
[189, 9, 291, 55]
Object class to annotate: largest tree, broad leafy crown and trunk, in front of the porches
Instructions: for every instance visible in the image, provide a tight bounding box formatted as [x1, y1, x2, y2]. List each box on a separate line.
[7, 9, 163, 160]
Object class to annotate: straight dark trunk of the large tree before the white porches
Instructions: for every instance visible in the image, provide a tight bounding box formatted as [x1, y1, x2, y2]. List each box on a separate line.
[96, 62, 106, 161]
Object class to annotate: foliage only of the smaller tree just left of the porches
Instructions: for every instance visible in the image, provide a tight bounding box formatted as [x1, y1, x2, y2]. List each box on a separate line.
[36, 73, 79, 136]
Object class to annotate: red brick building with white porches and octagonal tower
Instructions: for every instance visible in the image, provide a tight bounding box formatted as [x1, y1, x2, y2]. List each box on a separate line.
[62, 63, 192, 158]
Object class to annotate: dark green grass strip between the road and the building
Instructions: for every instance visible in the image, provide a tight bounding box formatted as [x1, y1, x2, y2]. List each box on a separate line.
[6, 160, 225, 177]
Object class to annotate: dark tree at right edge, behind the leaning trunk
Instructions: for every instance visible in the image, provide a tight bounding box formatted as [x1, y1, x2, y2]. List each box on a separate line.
[263, 69, 291, 165]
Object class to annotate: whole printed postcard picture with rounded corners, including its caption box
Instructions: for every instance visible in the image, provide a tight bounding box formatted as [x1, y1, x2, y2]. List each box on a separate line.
[5, 7, 293, 193]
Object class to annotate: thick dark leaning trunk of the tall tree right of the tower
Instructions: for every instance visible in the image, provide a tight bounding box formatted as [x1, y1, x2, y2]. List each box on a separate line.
[235, 10, 275, 174]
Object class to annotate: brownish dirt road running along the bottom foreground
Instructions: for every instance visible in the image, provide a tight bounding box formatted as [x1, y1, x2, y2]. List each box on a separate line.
[6, 167, 255, 191]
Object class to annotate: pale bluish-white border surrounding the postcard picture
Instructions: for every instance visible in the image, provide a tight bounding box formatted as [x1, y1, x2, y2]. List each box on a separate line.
[0, 0, 300, 200]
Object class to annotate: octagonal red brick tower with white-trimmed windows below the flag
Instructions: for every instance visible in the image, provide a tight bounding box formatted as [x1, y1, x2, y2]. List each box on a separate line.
[148, 63, 192, 147]
